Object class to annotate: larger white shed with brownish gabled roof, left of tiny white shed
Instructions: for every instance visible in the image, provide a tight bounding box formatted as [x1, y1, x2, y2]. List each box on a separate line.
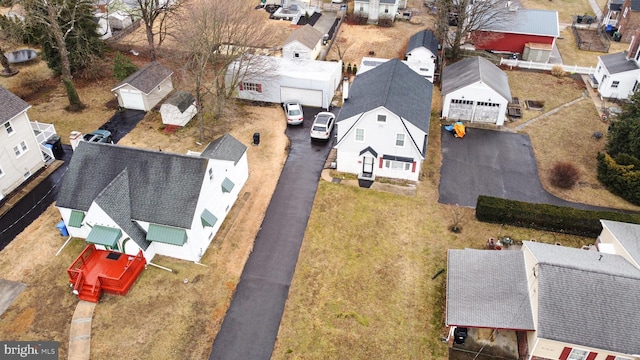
[111, 61, 173, 111]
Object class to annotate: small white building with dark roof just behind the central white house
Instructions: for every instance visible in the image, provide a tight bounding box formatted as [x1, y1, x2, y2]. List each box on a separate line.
[405, 30, 439, 82]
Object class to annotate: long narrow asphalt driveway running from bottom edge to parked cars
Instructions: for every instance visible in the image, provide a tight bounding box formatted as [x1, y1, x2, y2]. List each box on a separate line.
[209, 108, 331, 360]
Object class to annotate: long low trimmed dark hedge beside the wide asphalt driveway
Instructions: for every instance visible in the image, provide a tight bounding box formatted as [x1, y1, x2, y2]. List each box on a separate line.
[476, 195, 640, 238]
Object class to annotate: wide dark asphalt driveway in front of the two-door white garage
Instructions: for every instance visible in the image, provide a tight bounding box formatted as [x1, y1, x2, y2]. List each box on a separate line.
[438, 128, 610, 210]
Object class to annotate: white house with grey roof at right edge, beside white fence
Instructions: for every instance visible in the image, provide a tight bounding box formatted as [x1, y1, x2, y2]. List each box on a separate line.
[589, 27, 640, 99]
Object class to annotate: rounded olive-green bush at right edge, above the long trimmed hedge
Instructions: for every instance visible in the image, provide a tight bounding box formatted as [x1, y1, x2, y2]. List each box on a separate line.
[598, 153, 640, 205]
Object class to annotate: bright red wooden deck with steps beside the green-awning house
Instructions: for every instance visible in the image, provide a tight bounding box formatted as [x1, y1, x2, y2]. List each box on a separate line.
[67, 244, 147, 302]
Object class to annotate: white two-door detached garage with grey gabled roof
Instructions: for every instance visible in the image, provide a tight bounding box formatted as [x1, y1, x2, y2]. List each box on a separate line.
[442, 57, 511, 125]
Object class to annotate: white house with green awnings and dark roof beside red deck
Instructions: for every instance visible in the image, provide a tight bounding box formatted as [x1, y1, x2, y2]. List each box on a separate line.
[56, 134, 249, 262]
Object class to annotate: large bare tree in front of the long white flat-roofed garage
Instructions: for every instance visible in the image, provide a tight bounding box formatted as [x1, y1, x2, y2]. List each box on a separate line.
[177, 0, 271, 141]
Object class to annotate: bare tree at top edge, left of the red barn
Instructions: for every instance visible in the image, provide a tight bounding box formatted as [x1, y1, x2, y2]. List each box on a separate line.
[436, 0, 509, 61]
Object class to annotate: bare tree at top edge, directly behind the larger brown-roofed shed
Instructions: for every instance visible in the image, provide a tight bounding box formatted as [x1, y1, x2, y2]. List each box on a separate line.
[133, 0, 184, 61]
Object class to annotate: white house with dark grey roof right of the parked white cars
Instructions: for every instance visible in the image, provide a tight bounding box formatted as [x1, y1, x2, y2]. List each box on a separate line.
[335, 59, 433, 181]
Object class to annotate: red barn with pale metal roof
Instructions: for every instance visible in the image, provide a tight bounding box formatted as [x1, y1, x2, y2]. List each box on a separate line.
[471, 9, 560, 54]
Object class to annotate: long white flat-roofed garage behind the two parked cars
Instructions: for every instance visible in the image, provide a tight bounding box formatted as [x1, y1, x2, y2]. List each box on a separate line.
[226, 56, 342, 108]
